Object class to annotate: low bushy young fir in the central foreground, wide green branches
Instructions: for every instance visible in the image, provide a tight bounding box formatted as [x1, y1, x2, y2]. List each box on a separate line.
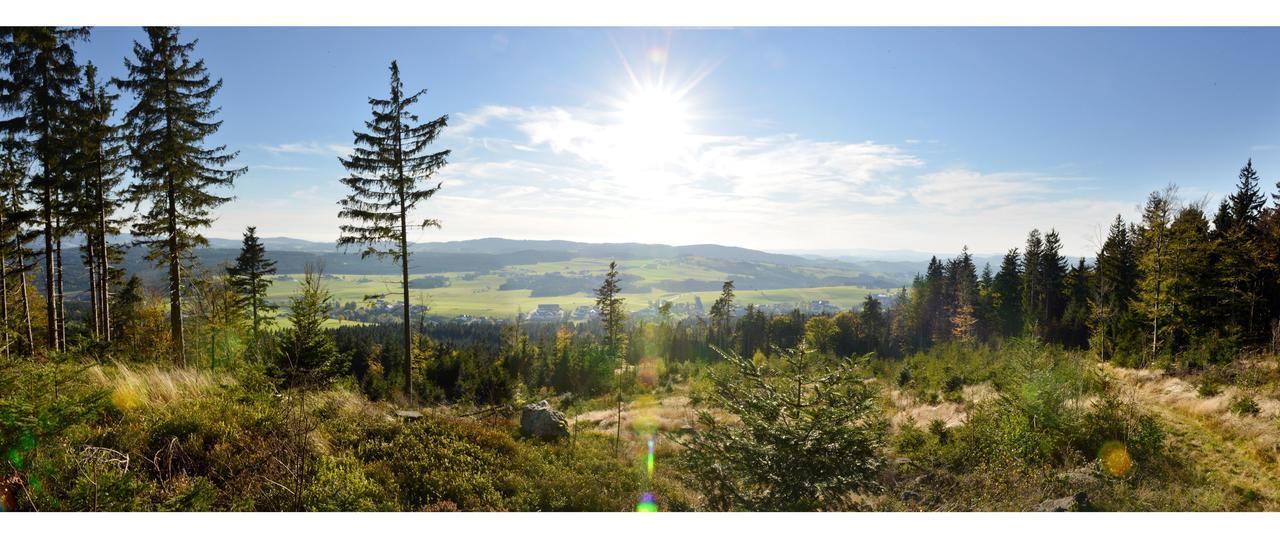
[669, 348, 888, 511]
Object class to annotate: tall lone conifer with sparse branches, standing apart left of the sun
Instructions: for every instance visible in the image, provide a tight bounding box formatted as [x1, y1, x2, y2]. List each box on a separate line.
[338, 61, 449, 398]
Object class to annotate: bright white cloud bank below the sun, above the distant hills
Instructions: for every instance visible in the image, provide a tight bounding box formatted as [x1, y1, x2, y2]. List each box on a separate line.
[219, 106, 1134, 253]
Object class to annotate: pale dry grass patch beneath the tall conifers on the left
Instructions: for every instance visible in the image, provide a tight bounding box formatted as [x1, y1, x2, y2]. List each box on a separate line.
[88, 364, 236, 410]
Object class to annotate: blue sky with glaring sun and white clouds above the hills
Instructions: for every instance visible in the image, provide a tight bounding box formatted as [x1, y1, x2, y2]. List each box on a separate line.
[79, 27, 1280, 253]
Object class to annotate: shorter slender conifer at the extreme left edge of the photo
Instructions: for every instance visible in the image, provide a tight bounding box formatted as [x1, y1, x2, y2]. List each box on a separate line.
[0, 134, 38, 356]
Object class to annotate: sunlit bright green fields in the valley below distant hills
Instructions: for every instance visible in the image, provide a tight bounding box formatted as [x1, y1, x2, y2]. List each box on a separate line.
[268, 259, 892, 318]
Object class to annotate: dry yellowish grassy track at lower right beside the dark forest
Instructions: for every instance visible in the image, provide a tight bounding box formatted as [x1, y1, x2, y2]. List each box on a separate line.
[1103, 365, 1280, 501]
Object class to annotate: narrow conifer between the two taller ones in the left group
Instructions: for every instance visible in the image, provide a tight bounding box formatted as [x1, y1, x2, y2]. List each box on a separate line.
[73, 64, 125, 342]
